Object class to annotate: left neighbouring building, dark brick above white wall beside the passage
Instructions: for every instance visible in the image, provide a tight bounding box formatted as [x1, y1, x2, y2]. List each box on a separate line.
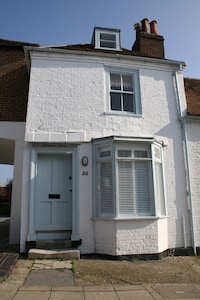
[0, 39, 38, 244]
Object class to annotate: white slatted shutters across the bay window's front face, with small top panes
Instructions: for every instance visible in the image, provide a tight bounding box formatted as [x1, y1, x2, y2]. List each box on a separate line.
[118, 149, 153, 216]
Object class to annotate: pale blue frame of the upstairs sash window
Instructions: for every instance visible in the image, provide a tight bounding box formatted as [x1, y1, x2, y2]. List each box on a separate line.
[105, 66, 142, 116]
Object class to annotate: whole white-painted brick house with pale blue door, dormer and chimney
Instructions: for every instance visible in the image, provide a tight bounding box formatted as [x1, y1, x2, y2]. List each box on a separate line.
[4, 19, 200, 256]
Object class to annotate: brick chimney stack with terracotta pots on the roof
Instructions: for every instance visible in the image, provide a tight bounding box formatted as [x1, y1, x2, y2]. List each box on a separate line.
[132, 18, 165, 59]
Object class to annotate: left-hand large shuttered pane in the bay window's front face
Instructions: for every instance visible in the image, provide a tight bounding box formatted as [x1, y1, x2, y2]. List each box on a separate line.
[118, 162, 134, 215]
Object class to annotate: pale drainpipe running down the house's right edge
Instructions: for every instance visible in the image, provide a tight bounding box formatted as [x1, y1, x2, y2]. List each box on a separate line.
[173, 64, 197, 255]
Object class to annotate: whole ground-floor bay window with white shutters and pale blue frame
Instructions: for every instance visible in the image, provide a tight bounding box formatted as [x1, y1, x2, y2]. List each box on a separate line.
[94, 138, 166, 218]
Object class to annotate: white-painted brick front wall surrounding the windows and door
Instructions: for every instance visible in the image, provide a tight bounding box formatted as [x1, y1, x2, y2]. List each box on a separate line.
[21, 53, 191, 255]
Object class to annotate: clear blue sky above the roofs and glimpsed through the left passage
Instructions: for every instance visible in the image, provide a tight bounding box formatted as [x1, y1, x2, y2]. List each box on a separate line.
[0, 0, 200, 184]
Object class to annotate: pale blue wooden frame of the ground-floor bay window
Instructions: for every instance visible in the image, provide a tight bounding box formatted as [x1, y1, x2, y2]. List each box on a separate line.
[93, 137, 167, 219]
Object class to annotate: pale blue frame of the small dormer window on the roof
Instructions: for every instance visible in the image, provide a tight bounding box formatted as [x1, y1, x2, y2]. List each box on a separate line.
[95, 28, 121, 51]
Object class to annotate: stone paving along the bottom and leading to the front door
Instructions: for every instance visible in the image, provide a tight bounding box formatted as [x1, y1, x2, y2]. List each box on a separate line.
[0, 218, 200, 300]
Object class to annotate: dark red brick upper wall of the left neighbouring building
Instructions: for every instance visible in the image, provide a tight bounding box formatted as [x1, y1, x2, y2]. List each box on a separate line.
[0, 43, 29, 122]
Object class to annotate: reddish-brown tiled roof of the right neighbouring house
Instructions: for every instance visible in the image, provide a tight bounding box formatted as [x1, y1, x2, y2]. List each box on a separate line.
[184, 78, 200, 116]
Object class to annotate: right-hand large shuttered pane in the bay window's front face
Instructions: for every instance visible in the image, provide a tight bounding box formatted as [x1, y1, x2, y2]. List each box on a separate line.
[135, 161, 153, 216]
